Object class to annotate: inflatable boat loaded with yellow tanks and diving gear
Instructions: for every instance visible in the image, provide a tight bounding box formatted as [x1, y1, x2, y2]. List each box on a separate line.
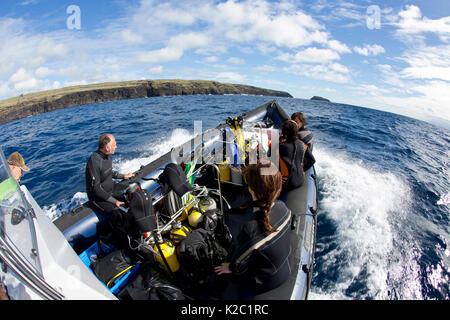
[0, 101, 318, 300]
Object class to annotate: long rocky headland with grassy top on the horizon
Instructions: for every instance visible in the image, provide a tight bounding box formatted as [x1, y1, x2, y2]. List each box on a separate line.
[0, 80, 292, 124]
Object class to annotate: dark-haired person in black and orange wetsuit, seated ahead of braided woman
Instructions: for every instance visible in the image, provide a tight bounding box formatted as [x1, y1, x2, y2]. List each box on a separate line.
[279, 120, 305, 191]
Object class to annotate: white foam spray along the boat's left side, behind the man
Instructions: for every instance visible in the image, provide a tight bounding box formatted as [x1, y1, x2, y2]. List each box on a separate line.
[42, 129, 193, 221]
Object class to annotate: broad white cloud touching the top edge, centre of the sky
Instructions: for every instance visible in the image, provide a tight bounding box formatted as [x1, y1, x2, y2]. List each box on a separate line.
[130, 0, 329, 48]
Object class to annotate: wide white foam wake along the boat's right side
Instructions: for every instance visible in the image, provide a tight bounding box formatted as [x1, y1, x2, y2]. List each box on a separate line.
[309, 148, 417, 300]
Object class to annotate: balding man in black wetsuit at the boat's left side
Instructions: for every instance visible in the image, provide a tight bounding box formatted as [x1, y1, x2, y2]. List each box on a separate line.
[86, 133, 134, 232]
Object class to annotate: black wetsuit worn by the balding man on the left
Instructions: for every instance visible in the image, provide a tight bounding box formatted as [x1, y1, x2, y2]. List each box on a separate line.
[86, 150, 126, 220]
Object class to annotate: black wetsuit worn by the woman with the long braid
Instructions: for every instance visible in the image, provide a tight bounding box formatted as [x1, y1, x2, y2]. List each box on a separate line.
[230, 201, 292, 298]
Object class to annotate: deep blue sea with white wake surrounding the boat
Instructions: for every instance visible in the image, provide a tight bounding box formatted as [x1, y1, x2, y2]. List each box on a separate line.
[0, 95, 450, 300]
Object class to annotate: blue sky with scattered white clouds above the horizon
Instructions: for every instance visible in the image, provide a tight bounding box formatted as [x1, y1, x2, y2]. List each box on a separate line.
[0, 0, 450, 129]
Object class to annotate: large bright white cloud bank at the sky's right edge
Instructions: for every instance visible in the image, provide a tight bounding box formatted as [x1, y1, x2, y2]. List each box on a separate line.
[354, 5, 450, 123]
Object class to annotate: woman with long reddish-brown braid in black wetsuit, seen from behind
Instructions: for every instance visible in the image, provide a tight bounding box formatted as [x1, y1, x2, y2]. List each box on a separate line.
[215, 160, 292, 299]
